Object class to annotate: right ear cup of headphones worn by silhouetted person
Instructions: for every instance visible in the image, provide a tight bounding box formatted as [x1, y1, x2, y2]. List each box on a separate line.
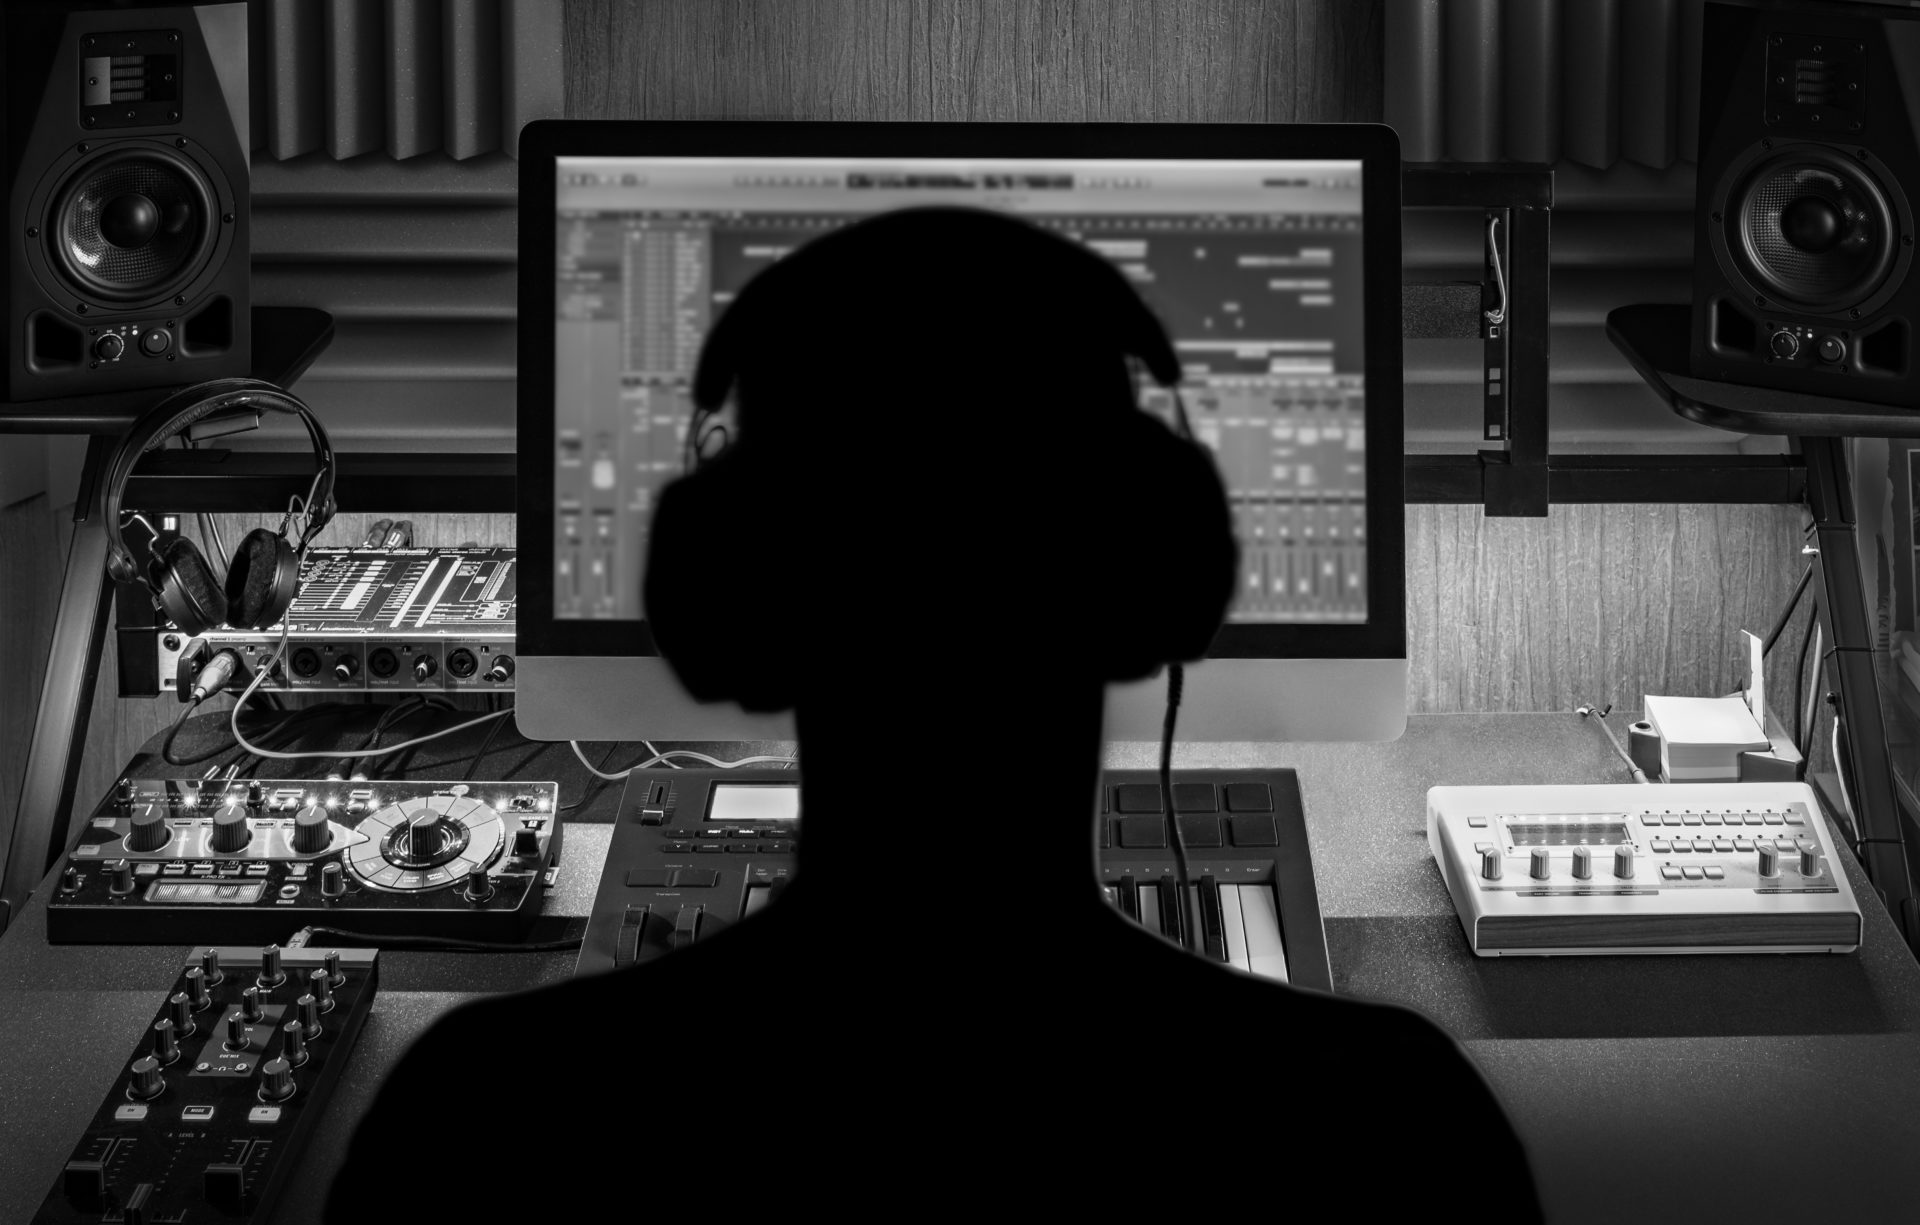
[1094, 420, 1240, 682]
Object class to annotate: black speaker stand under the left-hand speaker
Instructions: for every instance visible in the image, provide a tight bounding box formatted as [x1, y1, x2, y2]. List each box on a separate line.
[0, 307, 334, 933]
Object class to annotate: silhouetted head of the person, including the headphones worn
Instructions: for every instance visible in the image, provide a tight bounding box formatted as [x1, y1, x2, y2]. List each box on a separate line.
[645, 207, 1235, 710]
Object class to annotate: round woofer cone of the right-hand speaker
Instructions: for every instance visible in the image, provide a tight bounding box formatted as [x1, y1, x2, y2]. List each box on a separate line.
[1720, 144, 1901, 313]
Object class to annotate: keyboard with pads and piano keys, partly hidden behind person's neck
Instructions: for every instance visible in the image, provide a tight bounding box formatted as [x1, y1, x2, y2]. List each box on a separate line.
[576, 770, 1332, 991]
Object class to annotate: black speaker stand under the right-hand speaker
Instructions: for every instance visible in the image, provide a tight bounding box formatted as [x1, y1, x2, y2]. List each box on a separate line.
[1607, 305, 1920, 949]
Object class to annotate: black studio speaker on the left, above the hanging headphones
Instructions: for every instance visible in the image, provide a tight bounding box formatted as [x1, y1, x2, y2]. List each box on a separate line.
[0, 4, 252, 401]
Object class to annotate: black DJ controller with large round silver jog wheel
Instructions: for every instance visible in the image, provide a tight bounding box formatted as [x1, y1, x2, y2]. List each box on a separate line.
[46, 778, 561, 945]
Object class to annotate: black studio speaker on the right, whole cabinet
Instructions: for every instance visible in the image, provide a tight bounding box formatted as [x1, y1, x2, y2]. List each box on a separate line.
[1692, 4, 1920, 411]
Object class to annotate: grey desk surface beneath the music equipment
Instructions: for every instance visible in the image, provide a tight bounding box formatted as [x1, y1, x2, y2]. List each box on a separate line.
[0, 714, 1920, 1225]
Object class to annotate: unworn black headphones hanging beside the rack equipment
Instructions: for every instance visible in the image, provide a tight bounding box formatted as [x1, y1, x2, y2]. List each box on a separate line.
[102, 378, 336, 634]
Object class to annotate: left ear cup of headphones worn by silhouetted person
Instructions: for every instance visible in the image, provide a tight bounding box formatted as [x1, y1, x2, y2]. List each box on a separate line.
[641, 455, 801, 712]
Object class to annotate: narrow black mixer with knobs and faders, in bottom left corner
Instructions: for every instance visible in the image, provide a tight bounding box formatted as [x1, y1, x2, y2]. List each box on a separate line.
[33, 945, 376, 1225]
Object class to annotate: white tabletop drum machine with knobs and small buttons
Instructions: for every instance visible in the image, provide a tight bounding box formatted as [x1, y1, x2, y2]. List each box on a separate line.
[1427, 783, 1860, 956]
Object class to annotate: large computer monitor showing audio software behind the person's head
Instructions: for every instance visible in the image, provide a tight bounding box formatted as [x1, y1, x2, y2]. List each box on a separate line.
[516, 121, 1407, 741]
